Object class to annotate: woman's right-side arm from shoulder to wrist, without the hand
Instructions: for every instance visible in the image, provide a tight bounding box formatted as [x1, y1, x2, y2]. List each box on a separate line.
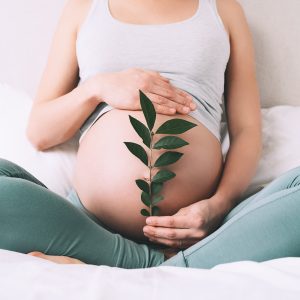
[211, 0, 262, 214]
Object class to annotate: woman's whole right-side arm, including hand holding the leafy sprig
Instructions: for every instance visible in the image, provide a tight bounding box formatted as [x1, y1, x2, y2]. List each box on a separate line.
[143, 0, 262, 248]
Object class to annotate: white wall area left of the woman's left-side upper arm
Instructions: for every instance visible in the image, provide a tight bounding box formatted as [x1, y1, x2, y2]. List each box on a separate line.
[0, 0, 65, 95]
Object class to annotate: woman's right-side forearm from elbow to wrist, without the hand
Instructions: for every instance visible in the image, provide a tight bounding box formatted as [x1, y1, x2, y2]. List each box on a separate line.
[211, 129, 261, 214]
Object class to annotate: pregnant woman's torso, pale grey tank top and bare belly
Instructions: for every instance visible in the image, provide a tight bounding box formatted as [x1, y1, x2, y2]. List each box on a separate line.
[74, 0, 229, 239]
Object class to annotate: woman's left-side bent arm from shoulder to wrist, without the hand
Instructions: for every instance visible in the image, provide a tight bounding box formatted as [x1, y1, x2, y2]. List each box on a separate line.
[26, 0, 99, 150]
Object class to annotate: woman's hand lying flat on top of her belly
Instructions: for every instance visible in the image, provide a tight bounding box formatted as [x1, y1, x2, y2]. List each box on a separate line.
[85, 68, 196, 115]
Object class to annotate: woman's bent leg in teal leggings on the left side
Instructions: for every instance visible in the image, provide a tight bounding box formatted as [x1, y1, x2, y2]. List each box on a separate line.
[0, 159, 164, 268]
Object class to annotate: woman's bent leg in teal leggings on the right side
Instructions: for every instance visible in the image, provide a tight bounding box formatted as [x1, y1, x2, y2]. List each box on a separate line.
[161, 167, 300, 268]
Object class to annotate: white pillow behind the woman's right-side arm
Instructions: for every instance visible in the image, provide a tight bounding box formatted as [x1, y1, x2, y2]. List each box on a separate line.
[222, 105, 300, 198]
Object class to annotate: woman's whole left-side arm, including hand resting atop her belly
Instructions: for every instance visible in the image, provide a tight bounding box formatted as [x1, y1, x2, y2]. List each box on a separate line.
[26, 0, 196, 150]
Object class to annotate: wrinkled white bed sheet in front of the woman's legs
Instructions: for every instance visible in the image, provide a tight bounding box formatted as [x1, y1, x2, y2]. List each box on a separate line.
[0, 250, 300, 300]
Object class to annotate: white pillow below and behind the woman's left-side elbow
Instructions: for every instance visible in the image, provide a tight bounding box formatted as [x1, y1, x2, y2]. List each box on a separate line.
[0, 83, 78, 196]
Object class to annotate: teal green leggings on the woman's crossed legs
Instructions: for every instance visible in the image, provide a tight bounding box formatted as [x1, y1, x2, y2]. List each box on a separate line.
[0, 159, 300, 269]
